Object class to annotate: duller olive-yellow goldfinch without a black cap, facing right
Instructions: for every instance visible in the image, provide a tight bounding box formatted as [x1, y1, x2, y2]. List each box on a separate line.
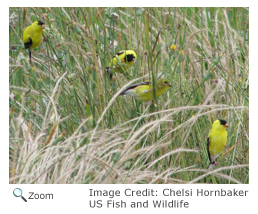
[120, 79, 172, 102]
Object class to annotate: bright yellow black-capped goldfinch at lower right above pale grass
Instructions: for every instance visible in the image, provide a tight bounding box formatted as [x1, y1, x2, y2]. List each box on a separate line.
[207, 119, 228, 169]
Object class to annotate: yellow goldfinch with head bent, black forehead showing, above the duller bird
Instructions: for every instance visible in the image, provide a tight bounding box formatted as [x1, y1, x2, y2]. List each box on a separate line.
[107, 50, 137, 79]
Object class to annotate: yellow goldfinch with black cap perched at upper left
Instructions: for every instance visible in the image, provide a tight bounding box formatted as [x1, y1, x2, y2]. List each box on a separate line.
[23, 21, 45, 63]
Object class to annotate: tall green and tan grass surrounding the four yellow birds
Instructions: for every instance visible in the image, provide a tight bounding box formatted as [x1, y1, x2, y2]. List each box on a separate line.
[9, 8, 249, 184]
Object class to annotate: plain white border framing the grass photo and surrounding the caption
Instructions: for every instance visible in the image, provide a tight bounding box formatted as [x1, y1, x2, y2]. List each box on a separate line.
[4, 0, 258, 214]
